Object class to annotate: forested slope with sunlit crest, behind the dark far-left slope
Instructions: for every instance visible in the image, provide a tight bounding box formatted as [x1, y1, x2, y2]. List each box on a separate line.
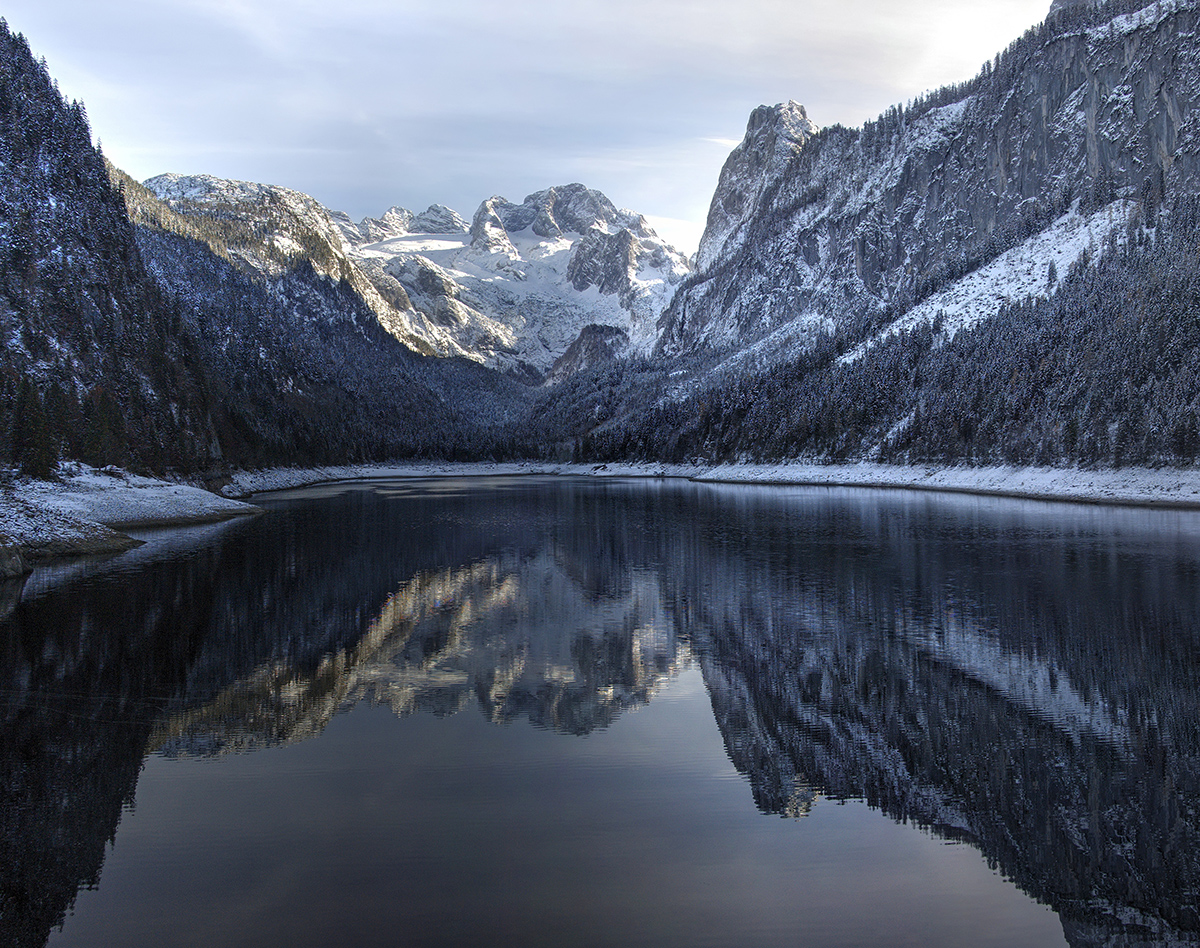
[124, 172, 520, 466]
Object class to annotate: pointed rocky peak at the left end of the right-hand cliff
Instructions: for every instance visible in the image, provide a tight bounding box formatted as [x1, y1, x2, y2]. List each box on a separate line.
[696, 101, 820, 270]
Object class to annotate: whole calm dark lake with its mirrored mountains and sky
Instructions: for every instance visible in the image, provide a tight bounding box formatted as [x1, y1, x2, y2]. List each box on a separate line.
[0, 478, 1200, 948]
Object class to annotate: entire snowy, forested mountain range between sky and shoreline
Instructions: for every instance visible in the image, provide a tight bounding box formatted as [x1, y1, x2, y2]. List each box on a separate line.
[0, 0, 1200, 476]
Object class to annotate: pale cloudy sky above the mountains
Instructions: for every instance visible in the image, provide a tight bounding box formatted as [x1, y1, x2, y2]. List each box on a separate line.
[4, 0, 1050, 252]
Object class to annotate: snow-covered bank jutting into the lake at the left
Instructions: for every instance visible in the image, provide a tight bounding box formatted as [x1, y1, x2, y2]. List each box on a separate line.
[0, 463, 258, 572]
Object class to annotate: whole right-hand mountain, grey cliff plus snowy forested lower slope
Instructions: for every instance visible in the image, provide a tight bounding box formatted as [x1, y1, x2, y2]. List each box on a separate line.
[528, 0, 1200, 464]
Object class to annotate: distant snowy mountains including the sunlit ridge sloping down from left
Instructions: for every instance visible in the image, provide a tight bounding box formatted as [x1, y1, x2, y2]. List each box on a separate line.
[144, 174, 688, 382]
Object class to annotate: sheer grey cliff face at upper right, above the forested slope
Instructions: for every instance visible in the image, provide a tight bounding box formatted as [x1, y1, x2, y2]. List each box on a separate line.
[659, 0, 1200, 354]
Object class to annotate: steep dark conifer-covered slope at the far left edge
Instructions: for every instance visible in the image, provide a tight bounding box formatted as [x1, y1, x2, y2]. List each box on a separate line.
[0, 23, 221, 473]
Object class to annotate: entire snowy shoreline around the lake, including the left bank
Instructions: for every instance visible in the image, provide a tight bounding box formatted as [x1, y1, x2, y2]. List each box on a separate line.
[7, 462, 1200, 578]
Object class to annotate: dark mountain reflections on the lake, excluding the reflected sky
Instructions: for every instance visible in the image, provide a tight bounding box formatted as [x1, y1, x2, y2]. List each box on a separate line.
[0, 479, 1200, 946]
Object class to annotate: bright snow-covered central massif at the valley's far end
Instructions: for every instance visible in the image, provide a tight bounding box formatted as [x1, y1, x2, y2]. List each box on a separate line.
[337, 184, 689, 380]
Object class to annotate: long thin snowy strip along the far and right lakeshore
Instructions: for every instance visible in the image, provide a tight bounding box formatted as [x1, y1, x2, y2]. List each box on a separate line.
[224, 462, 1200, 508]
